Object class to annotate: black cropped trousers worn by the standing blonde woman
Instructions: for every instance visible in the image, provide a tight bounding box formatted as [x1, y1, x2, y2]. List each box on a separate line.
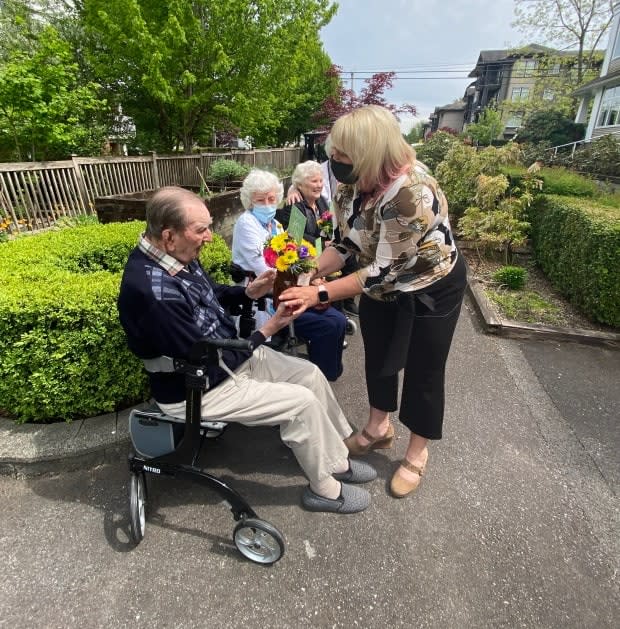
[359, 256, 467, 439]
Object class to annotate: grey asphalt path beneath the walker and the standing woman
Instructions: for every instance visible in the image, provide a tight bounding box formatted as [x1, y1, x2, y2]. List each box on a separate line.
[0, 298, 620, 629]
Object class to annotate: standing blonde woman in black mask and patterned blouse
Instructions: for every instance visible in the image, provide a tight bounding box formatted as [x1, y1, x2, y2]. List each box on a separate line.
[282, 105, 466, 498]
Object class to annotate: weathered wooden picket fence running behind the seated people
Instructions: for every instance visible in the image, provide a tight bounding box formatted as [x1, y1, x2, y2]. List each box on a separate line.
[0, 147, 303, 235]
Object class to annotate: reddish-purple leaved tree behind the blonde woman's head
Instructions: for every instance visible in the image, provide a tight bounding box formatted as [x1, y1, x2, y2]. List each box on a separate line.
[315, 65, 417, 133]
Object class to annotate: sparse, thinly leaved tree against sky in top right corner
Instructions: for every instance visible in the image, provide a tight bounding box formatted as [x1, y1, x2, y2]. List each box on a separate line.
[513, 0, 617, 83]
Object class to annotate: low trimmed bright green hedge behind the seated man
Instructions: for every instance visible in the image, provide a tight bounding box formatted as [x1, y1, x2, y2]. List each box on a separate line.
[0, 222, 230, 422]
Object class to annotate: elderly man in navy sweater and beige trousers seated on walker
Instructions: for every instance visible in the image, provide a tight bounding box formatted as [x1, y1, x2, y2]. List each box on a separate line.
[118, 187, 376, 513]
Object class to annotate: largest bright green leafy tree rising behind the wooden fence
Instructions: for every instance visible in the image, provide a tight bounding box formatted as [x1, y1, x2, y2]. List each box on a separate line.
[81, 0, 336, 152]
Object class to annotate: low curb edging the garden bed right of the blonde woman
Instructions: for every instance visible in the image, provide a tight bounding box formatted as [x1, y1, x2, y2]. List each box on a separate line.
[467, 276, 620, 350]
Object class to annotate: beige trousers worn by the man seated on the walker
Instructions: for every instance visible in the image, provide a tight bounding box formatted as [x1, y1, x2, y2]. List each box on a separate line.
[158, 345, 352, 484]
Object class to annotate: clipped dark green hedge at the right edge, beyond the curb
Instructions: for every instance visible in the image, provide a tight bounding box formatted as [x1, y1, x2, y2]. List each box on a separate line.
[530, 195, 620, 328]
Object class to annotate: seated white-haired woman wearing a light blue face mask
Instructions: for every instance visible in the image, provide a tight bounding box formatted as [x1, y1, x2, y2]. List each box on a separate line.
[232, 169, 346, 381]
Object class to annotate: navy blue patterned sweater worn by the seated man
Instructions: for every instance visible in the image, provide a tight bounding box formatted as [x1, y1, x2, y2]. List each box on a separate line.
[118, 247, 265, 404]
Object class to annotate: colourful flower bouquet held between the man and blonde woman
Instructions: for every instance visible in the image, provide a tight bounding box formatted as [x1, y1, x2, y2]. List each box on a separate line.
[263, 232, 316, 308]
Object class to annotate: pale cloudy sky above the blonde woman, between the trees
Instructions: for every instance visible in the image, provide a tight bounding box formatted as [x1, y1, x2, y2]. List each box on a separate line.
[321, 0, 529, 133]
